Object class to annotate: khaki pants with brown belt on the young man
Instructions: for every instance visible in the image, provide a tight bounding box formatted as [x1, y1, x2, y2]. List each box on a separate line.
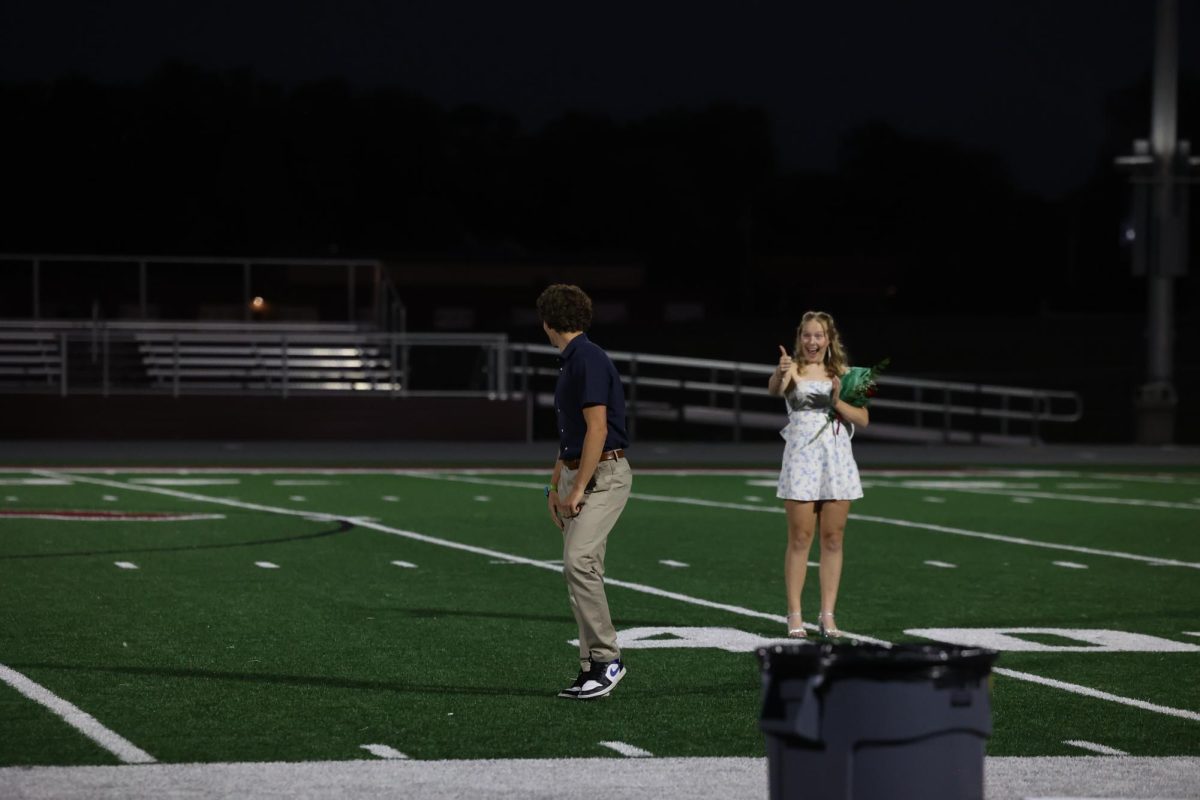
[558, 458, 634, 672]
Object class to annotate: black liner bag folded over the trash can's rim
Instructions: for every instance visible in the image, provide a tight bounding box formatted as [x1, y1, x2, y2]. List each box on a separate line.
[757, 642, 998, 680]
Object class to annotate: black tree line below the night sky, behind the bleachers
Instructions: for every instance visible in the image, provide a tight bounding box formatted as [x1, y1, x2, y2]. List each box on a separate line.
[0, 64, 1200, 313]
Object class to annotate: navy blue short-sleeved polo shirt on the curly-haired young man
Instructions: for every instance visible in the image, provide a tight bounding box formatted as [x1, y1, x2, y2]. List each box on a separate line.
[554, 333, 629, 461]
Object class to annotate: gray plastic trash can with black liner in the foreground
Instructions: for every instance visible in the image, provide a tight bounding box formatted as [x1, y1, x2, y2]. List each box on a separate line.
[758, 642, 996, 800]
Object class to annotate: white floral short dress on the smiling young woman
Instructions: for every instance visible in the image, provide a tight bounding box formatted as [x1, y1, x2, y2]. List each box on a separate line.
[775, 380, 863, 500]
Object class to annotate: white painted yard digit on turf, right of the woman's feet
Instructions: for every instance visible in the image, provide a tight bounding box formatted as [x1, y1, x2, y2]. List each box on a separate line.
[905, 627, 1200, 652]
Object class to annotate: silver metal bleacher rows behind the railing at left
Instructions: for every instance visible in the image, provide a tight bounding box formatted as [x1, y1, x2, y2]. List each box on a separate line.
[0, 320, 508, 397]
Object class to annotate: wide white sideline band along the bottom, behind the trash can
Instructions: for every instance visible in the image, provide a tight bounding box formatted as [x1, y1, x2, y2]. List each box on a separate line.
[0, 753, 1200, 800]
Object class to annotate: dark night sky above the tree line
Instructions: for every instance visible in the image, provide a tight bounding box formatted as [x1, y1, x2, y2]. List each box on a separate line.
[0, 0, 1200, 197]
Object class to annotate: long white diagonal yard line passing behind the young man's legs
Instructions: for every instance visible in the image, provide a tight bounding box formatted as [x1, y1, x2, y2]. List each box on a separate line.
[37, 473, 1200, 722]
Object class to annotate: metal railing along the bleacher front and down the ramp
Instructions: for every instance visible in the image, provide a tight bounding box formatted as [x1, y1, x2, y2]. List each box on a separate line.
[0, 321, 1082, 445]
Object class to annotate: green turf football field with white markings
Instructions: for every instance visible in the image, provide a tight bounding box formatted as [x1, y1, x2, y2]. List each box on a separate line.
[0, 463, 1200, 766]
